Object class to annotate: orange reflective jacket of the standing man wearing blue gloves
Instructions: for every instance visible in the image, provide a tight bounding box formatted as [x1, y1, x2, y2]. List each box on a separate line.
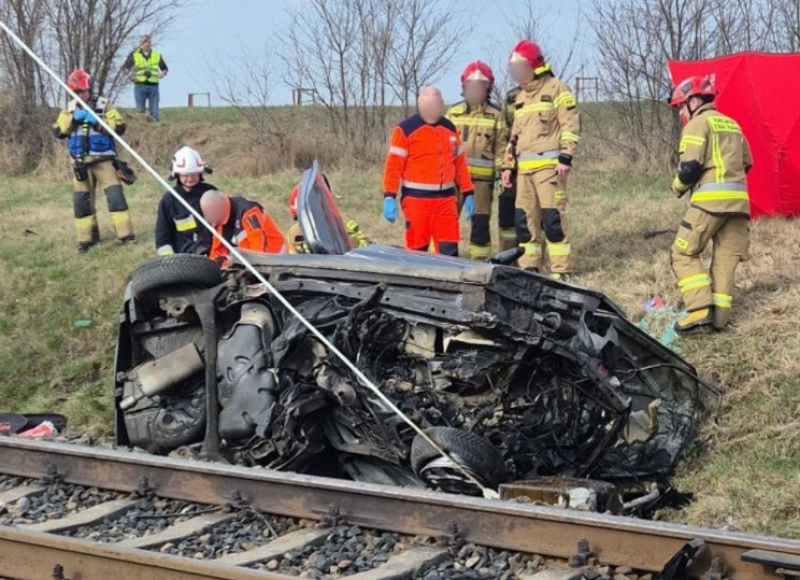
[383, 114, 474, 198]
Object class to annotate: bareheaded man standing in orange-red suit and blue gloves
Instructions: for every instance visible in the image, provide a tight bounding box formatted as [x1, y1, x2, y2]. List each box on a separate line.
[383, 87, 475, 256]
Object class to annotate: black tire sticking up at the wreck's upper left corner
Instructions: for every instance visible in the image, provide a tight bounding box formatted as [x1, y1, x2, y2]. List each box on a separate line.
[131, 254, 222, 299]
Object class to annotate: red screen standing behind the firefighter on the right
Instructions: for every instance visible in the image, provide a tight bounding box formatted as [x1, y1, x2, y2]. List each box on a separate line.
[669, 52, 800, 217]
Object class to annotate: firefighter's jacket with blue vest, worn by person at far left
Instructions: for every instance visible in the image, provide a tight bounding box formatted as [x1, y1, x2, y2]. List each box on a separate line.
[53, 97, 125, 163]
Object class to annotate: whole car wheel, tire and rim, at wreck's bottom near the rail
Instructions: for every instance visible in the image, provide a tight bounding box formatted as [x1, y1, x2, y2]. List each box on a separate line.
[411, 427, 505, 495]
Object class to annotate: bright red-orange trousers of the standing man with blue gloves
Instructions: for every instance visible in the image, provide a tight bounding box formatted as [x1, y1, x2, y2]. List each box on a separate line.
[400, 195, 460, 256]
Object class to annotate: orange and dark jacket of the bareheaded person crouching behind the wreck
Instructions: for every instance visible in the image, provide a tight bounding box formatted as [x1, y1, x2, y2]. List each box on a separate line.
[208, 197, 285, 268]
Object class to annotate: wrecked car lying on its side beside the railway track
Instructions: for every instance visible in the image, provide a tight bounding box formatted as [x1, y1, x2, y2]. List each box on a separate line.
[115, 164, 700, 500]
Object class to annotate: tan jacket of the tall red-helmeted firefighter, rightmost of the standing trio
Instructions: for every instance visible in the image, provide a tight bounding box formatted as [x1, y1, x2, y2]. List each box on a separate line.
[503, 73, 580, 173]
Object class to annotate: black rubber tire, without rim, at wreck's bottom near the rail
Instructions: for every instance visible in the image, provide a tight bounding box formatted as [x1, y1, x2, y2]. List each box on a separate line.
[411, 427, 506, 488]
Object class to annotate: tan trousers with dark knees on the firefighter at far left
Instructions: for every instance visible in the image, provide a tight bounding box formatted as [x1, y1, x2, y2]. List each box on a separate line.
[72, 160, 133, 244]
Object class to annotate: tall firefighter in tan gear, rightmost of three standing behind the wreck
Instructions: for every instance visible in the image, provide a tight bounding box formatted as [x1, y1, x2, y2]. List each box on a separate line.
[503, 40, 580, 280]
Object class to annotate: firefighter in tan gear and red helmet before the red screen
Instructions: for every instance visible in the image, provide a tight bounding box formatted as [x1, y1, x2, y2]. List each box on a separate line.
[670, 76, 753, 332]
